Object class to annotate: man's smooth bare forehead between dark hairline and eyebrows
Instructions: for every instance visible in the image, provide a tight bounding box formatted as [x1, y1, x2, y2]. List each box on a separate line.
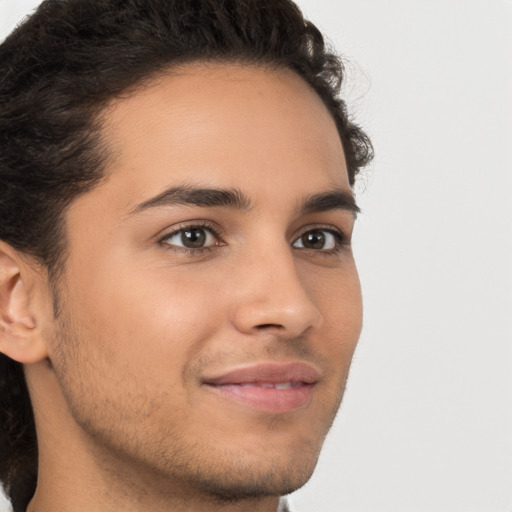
[67, 64, 350, 231]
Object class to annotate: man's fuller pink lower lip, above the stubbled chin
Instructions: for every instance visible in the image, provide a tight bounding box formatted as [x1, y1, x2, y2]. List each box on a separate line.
[203, 384, 314, 413]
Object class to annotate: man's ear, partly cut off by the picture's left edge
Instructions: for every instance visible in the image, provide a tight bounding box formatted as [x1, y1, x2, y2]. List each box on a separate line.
[0, 241, 48, 364]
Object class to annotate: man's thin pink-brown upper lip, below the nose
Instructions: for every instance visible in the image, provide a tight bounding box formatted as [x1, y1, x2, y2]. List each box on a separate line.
[203, 362, 321, 386]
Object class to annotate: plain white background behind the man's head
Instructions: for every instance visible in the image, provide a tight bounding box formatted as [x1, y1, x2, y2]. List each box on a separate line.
[0, 0, 512, 512]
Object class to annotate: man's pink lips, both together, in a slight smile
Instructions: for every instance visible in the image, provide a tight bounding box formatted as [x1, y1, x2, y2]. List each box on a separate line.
[203, 362, 321, 413]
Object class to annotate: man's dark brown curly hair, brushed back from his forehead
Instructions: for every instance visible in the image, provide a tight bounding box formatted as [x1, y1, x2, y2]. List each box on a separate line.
[0, 0, 373, 512]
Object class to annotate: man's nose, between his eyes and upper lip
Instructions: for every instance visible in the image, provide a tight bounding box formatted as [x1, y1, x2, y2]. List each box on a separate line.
[232, 246, 323, 338]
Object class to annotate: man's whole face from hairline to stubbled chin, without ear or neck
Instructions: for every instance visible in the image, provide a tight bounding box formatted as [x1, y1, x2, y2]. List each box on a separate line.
[48, 64, 362, 497]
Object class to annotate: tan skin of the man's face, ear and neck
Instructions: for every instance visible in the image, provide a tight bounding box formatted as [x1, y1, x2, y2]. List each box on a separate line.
[0, 63, 362, 512]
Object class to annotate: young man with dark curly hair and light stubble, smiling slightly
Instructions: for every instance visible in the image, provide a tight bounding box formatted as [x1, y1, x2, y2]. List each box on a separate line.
[0, 0, 371, 512]
